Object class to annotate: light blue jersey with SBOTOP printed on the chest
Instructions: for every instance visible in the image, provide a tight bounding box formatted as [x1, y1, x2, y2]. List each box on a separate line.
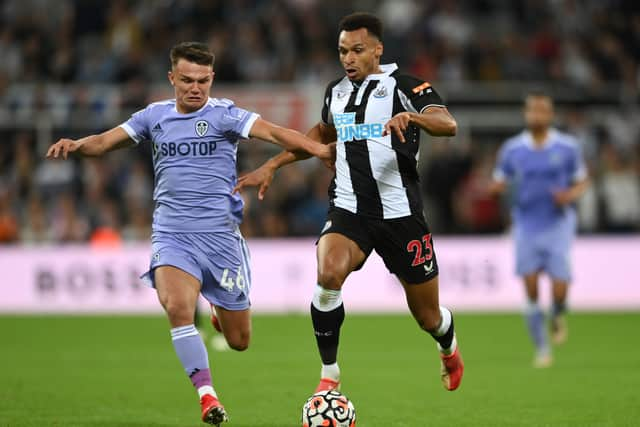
[121, 98, 259, 233]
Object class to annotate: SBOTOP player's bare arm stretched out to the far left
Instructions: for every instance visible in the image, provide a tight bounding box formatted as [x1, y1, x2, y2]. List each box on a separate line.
[47, 126, 134, 159]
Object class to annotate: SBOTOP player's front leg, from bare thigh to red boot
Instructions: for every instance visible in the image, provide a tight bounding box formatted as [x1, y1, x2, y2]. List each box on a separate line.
[154, 266, 227, 425]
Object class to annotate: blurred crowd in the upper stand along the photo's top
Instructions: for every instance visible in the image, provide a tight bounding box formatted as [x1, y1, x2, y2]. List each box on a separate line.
[0, 0, 640, 86]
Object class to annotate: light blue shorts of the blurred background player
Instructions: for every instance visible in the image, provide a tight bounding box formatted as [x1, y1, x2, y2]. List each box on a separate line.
[514, 216, 576, 282]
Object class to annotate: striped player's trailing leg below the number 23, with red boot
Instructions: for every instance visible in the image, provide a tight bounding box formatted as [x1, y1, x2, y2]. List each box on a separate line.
[400, 276, 464, 391]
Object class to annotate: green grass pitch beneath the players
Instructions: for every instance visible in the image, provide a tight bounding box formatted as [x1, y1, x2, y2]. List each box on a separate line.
[0, 313, 640, 427]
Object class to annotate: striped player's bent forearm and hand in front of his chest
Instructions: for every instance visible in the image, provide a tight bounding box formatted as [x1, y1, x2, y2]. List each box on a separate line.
[382, 106, 458, 142]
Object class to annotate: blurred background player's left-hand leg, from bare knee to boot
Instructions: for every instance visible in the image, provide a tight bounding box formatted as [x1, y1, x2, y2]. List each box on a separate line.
[524, 273, 553, 368]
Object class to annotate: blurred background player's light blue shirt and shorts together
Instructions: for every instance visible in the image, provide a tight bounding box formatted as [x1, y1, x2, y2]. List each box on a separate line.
[494, 129, 586, 282]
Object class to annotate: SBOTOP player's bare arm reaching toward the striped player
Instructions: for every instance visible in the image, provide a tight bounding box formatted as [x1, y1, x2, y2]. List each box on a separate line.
[249, 118, 335, 160]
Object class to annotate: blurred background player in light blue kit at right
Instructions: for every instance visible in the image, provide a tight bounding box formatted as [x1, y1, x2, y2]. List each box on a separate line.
[490, 93, 588, 367]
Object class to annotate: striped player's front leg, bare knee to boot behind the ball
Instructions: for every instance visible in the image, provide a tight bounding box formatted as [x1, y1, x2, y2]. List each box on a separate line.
[311, 233, 366, 392]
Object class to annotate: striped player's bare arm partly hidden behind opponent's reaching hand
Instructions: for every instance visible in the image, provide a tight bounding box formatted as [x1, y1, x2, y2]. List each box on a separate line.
[233, 122, 336, 200]
